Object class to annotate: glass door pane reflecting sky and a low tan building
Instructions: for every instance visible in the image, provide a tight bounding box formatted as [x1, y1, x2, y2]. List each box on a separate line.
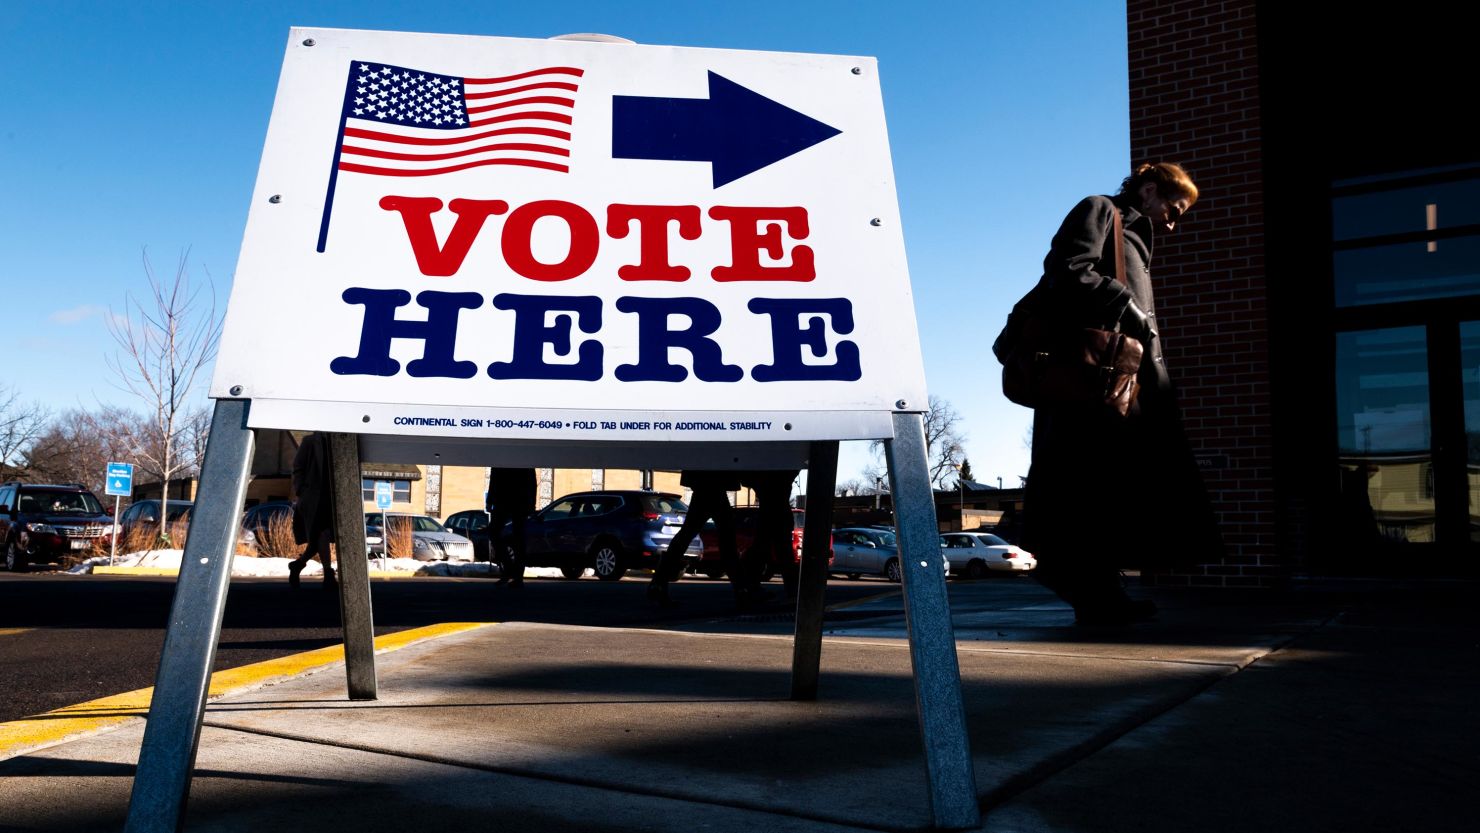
[1336, 327, 1426, 549]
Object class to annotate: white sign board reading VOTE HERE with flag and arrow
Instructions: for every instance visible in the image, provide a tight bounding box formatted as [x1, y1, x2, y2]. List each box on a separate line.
[212, 30, 926, 442]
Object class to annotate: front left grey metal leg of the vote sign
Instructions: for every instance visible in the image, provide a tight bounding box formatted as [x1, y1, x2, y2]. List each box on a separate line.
[124, 399, 253, 833]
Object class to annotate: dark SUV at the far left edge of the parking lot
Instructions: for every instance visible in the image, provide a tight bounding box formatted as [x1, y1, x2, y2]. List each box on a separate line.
[0, 482, 114, 571]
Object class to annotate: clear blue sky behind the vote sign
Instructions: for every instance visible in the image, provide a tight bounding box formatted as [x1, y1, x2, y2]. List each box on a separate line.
[0, 0, 1131, 485]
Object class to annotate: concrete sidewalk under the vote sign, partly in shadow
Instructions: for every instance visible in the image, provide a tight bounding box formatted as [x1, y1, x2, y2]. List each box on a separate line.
[0, 580, 1480, 833]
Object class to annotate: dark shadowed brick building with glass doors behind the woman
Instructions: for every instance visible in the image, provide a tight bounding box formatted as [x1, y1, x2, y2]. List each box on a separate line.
[1128, 0, 1480, 586]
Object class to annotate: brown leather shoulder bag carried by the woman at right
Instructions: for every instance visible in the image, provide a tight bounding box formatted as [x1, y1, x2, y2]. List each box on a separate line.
[992, 210, 1146, 417]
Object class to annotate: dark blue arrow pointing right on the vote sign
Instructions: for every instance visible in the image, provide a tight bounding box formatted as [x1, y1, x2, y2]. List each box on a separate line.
[611, 72, 842, 188]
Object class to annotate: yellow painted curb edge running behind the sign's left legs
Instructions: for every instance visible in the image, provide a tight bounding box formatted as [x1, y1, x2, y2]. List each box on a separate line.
[0, 621, 494, 761]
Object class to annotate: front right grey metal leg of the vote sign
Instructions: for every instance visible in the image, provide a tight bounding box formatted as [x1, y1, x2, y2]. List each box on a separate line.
[884, 413, 981, 829]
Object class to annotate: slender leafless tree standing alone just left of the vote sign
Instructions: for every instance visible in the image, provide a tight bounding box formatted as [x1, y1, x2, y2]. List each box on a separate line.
[108, 250, 221, 544]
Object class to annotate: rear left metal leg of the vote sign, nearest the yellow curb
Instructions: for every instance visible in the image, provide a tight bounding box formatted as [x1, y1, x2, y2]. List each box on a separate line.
[329, 434, 375, 700]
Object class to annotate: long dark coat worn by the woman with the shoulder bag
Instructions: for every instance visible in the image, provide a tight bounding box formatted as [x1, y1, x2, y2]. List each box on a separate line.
[1023, 197, 1222, 567]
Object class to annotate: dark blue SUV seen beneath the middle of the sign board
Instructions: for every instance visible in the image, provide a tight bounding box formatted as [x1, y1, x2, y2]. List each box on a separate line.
[505, 490, 703, 581]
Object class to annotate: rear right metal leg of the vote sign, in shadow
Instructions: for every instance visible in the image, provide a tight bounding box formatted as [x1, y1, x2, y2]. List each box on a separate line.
[792, 441, 838, 700]
